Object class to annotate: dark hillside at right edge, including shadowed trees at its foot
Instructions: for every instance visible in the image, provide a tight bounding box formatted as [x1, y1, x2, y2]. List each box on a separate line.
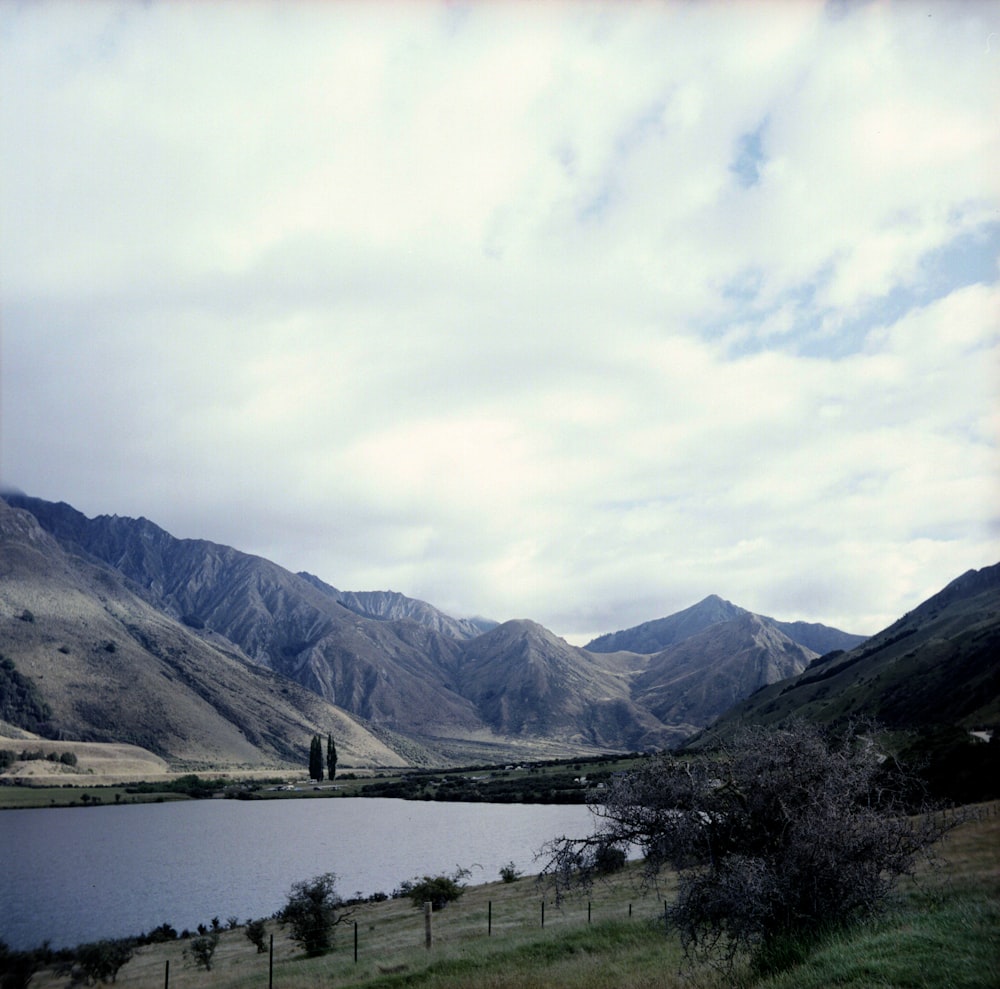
[685, 564, 1000, 803]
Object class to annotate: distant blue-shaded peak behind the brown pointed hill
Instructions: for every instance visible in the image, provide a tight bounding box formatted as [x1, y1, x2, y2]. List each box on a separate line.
[585, 594, 865, 654]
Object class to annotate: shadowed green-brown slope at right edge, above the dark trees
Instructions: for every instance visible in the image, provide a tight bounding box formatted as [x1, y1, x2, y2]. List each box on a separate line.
[694, 564, 1000, 745]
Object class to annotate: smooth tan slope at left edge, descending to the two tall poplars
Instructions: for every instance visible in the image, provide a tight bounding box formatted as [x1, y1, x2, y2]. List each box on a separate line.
[0, 501, 401, 767]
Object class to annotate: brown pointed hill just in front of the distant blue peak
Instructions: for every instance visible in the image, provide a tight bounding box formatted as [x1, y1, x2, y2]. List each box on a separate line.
[633, 612, 816, 731]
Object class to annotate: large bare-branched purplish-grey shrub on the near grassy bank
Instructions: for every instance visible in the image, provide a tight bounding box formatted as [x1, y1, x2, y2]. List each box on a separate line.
[545, 723, 946, 963]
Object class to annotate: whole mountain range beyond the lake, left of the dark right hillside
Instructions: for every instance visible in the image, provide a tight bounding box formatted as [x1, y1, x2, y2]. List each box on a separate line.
[0, 493, 992, 767]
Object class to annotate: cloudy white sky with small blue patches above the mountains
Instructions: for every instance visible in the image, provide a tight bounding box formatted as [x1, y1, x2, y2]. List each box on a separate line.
[0, 0, 1000, 644]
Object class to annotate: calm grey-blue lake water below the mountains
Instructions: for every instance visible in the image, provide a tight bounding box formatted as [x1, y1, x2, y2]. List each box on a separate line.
[0, 798, 593, 949]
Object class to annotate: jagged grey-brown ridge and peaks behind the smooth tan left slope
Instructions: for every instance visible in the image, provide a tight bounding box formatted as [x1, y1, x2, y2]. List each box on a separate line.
[0, 495, 888, 761]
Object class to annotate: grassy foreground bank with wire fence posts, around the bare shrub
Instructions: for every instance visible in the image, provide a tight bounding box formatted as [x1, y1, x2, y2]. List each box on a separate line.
[23, 804, 1000, 989]
